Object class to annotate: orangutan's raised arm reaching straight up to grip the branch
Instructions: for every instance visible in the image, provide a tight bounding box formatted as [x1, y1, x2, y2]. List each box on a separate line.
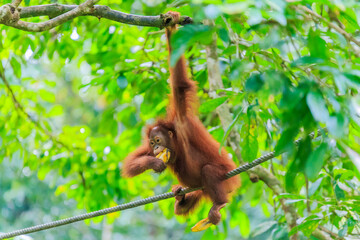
[166, 12, 197, 116]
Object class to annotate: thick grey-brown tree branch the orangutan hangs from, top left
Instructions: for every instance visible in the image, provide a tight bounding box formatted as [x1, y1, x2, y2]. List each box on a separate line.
[0, 0, 193, 32]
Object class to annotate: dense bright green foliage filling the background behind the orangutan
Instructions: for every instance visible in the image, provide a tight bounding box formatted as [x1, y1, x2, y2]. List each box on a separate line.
[0, 0, 360, 239]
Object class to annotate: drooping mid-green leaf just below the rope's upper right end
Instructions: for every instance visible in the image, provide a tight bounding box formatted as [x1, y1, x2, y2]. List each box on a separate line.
[305, 143, 328, 181]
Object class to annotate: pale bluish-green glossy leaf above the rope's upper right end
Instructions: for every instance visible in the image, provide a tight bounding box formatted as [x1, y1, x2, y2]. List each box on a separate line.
[306, 92, 329, 122]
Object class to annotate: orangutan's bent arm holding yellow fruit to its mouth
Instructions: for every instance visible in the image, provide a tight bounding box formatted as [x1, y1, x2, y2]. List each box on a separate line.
[122, 142, 166, 177]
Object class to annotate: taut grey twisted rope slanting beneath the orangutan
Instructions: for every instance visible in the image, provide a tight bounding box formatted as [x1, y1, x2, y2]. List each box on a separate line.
[0, 129, 326, 239]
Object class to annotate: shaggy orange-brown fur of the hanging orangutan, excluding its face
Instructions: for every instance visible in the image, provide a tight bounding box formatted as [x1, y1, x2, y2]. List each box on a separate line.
[123, 12, 240, 224]
